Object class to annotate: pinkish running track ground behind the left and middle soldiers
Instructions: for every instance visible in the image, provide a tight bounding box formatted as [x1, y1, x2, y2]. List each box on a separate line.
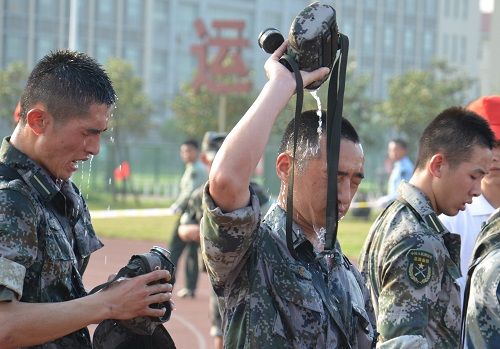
[83, 238, 213, 349]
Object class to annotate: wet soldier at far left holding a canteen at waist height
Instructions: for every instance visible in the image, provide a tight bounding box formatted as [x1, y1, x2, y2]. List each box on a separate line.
[0, 51, 172, 349]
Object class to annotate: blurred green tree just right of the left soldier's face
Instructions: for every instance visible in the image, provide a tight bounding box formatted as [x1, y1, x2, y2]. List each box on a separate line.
[106, 58, 153, 200]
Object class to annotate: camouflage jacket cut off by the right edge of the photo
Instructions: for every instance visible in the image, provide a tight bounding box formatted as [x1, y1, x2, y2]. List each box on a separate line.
[465, 209, 500, 349]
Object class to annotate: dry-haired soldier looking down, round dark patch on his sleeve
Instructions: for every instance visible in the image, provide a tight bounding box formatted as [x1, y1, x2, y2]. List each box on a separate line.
[360, 108, 495, 349]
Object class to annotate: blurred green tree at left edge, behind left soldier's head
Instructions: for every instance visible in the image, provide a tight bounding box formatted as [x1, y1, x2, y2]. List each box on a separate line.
[0, 63, 28, 122]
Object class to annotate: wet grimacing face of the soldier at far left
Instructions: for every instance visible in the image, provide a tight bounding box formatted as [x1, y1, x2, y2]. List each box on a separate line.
[34, 104, 112, 180]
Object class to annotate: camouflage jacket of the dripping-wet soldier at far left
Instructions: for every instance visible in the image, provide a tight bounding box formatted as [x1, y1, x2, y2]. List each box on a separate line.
[0, 138, 102, 349]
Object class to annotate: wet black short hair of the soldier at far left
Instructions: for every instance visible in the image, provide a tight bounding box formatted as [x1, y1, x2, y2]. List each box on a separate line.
[19, 50, 116, 122]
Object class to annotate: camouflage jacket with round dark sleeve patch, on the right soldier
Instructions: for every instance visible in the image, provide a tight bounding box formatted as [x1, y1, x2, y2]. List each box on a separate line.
[360, 182, 460, 349]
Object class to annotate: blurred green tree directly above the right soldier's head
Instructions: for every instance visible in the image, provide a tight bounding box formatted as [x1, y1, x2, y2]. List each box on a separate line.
[379, 61, 473, 151]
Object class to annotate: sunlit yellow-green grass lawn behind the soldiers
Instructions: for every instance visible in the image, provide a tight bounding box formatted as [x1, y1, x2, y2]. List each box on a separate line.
[92, 212, 372, 261]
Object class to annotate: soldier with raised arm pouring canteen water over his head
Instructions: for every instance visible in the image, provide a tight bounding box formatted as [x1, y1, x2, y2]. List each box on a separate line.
[201, 43, 375, 348]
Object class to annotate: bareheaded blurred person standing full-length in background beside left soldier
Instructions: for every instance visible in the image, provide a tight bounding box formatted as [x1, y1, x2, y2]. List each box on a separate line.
[168, 139, 207, 297]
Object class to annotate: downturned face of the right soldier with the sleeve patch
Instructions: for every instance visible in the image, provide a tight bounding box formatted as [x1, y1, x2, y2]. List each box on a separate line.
[432, 145, 492, 216]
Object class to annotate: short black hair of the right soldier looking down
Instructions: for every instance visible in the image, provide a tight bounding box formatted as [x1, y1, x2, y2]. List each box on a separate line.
[416, 107, 495, 169]
